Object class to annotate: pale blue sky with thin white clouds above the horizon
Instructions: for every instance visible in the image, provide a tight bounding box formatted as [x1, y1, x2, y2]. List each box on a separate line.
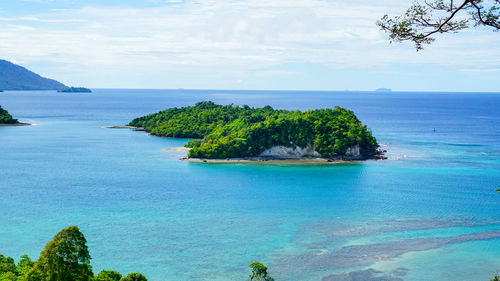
[0, 0, 500, 92]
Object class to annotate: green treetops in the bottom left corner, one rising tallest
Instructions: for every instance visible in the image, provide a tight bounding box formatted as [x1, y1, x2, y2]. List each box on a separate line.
[0, 226, 148, 281]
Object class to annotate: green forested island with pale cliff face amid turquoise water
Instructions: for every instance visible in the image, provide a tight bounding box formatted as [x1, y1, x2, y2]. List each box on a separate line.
[128, 101, 384, 162]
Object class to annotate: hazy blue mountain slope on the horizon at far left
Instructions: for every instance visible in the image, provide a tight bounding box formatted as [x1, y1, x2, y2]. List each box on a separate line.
[0, 60, 67, 90]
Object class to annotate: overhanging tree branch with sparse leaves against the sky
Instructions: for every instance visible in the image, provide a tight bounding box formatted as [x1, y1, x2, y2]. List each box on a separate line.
[377, 0, 500, 51]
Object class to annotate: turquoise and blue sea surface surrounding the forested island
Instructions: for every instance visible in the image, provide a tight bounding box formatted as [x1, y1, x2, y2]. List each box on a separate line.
[0, 89, 500, 281]
